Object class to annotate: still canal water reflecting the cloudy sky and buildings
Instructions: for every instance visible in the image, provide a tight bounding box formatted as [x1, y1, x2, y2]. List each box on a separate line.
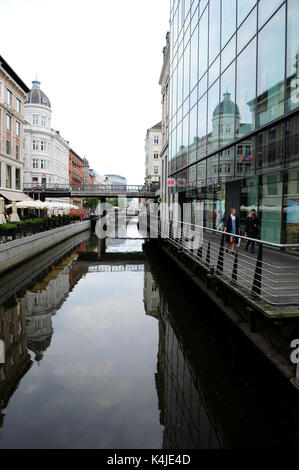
[0, 220, 299, 449]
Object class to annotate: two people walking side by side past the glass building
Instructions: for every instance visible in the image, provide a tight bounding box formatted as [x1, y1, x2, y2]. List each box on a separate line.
[224, 208, 259, 254]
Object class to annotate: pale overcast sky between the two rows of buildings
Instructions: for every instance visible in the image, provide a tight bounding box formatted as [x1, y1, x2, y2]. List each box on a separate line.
[0, 0, 170, 184]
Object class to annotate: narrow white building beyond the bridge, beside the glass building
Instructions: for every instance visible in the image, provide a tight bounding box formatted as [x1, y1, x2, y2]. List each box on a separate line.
[145, 122, 162, 184]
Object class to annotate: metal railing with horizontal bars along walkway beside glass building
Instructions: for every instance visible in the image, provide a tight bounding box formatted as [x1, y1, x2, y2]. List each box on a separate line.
[150, 215, 299, 306]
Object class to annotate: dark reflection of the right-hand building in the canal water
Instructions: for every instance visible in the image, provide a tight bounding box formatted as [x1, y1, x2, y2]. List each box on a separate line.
[144, 271, 221, 449]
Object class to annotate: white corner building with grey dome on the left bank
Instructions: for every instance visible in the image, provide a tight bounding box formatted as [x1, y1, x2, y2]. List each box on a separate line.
[24, 81, 69, 191]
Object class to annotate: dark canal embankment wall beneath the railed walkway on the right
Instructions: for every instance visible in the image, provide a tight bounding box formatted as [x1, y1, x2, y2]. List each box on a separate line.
[145, 241, 299, 390]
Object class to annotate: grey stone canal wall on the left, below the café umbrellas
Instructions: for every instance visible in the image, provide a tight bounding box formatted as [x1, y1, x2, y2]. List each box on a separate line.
[0, 220, 90, 275]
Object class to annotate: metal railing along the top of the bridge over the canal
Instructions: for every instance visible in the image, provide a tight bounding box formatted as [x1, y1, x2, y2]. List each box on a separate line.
[24, 183, 160, 196]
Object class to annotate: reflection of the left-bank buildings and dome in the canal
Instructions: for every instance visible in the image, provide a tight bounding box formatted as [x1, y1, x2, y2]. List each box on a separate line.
[0, 242, 87, 427]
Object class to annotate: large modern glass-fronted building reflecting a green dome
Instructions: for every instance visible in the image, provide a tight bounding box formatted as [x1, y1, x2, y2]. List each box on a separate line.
[168, 0, 299, 243]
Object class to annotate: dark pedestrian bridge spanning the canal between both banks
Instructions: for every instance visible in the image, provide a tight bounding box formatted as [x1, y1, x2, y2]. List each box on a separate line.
[24, 184, 160, 200]
